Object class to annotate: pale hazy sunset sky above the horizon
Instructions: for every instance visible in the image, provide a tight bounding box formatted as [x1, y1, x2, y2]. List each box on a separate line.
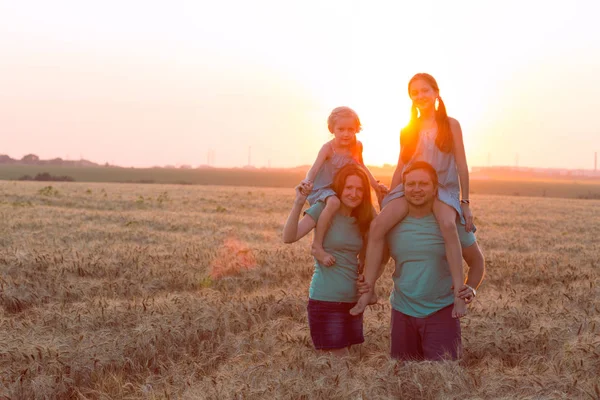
[0, 0, 600, 169]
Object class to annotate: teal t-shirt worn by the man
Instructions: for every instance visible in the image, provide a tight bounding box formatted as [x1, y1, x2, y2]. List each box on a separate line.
[387, 214, 475, 318]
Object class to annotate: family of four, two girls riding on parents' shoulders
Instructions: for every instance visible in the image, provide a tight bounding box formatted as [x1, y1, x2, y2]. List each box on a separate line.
[283, 73, 485, 360]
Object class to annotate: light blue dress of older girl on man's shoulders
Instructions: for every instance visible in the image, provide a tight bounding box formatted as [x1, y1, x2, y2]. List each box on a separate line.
[382, 131, 465, 225]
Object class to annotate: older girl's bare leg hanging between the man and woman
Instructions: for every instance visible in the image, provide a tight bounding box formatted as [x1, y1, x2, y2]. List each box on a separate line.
[350, 196, 408, 315]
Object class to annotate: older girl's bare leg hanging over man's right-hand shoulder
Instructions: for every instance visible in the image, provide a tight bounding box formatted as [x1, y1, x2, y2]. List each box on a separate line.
[433, 199, 467, 318]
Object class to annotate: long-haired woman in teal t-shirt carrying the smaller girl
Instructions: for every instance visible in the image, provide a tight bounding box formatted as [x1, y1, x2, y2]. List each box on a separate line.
[283, 164, 373, 356]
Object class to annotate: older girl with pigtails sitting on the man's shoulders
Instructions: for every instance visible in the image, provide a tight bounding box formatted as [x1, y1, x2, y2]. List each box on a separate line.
[359, 73, 475, 318]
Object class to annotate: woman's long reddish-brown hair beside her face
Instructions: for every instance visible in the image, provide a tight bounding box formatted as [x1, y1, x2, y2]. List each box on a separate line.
[332, 164, 374, 235]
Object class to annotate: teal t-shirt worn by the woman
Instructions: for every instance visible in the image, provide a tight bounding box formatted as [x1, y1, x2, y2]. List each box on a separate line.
[305, 201, 363, 303]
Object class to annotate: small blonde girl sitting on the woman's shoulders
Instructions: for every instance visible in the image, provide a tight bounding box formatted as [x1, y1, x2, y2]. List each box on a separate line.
[302, 107, 387, 267]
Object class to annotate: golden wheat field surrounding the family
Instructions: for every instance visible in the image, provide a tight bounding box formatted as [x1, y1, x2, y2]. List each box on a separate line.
[0, 182, 600, 399]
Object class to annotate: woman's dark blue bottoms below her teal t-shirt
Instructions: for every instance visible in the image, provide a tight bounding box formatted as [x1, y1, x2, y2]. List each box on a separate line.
[306, 299, 365, 350]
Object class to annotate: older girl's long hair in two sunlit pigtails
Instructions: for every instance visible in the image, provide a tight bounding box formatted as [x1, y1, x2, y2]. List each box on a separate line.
[400, 73, 452, 164]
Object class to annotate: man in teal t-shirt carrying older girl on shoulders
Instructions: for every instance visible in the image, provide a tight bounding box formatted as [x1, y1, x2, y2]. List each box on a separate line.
[350, 161, 485, 360]
